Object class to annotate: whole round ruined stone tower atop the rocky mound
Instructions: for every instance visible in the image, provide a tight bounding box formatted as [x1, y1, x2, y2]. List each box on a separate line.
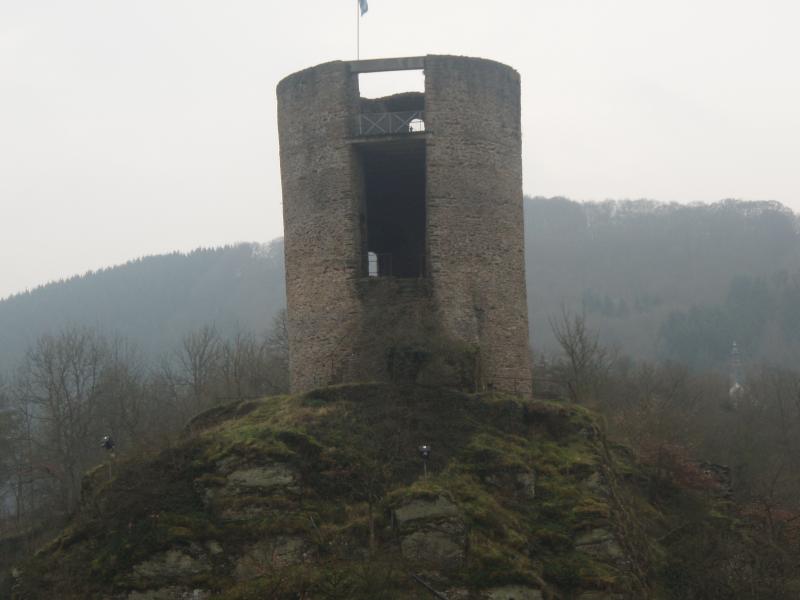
[277, 55, 531, 395]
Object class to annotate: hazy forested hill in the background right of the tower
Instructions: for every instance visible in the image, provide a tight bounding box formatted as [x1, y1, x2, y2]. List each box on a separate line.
[525, 198, 800, 367]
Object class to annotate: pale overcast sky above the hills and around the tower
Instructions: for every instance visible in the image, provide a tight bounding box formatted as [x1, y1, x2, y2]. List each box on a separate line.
[0, 0, 800, 298]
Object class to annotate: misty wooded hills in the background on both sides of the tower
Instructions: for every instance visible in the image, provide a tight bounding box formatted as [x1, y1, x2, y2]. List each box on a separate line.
[0, 198, 800, 371]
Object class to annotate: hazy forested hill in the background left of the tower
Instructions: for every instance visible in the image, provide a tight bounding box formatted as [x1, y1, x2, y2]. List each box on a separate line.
[0, 240, 286, 371]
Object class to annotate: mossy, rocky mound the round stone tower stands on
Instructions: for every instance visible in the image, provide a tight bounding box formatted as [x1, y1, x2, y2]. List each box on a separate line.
[3, 384, 744, 600]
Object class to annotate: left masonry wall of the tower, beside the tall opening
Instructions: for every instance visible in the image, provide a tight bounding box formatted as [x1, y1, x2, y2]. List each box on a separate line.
[278, 62, 361, 390]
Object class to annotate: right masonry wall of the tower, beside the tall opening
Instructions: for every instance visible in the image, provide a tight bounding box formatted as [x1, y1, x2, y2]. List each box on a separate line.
[425, 56, 530, 393]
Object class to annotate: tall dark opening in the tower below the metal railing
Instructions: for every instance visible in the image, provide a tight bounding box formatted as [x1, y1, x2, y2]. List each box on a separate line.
[358, 138, 426, 277]
